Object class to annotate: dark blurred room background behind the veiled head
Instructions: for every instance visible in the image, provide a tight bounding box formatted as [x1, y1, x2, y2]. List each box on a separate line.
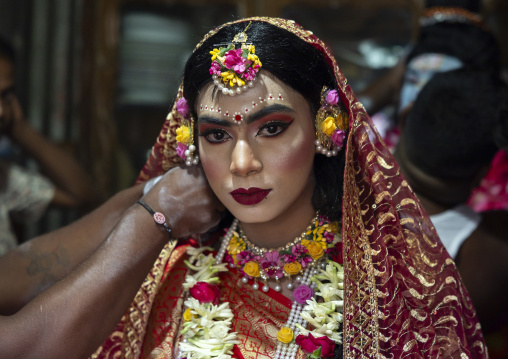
[0, 0, 508, 238]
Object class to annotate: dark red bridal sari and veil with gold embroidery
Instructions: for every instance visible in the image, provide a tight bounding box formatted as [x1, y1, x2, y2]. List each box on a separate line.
[91, 18, 488, 359]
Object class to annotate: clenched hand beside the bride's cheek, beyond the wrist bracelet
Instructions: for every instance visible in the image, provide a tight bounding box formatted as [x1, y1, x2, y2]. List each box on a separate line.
[142, 166, 225, 238]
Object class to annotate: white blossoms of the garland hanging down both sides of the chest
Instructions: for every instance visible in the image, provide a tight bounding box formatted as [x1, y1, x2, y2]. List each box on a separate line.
[179, 240, 344, 359]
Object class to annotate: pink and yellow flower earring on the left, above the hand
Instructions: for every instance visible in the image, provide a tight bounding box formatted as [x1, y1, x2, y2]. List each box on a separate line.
[176, 97, 199, 166]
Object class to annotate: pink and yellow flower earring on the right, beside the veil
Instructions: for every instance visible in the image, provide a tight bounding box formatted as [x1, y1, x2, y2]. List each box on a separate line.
[315, 87, 348, 157]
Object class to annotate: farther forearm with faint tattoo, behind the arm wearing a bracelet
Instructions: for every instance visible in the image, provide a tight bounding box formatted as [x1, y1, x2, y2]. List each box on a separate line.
[0, 185, 143, 315]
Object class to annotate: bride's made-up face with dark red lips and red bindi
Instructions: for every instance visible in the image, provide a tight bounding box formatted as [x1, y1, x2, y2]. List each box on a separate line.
[196, 71, 315, 223]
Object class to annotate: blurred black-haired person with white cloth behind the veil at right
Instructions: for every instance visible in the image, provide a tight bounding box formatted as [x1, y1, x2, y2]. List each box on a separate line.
[395, 69, 508, 358]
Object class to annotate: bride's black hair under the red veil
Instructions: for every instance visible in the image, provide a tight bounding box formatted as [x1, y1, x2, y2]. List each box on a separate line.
[184, 21, 345, 220]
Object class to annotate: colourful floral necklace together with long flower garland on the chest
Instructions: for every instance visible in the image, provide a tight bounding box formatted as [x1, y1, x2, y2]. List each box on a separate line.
[179, 214, 344, 359]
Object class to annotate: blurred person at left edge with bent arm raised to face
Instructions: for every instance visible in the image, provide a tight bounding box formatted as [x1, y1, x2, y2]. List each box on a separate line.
[0, 35, 95, 255]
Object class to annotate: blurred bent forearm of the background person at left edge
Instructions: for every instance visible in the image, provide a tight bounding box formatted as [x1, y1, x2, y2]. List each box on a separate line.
[11, 121, 96, 206]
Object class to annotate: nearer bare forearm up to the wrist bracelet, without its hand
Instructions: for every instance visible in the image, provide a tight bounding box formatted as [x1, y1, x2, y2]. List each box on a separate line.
[0, 205, 168, 359]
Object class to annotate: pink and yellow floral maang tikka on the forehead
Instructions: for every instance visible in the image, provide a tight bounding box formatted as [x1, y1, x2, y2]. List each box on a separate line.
[210, 23, 262, 95]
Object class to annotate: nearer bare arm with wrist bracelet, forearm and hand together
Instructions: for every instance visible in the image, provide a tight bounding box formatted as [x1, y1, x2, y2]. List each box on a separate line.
[0, 168, 223, 359]
